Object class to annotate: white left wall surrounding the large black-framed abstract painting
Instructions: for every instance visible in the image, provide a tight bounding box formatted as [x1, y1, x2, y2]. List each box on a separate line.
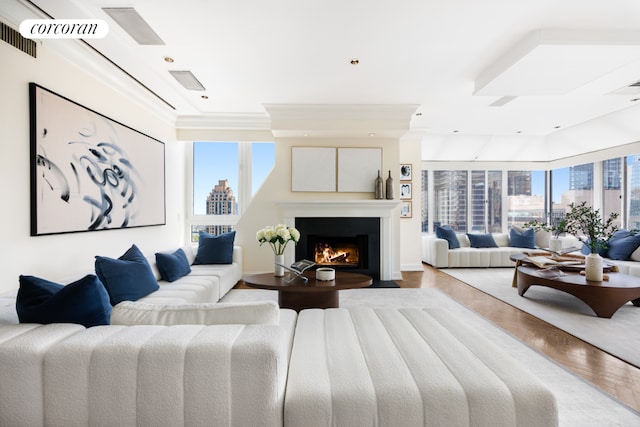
[0, 42, 185, 292]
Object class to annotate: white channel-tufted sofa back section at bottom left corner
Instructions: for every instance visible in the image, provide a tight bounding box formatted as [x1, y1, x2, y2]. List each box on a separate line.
[0, 310, 296, 427]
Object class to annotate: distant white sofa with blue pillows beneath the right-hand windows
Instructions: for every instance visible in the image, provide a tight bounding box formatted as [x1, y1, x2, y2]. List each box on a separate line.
[422, 233, 580, 268]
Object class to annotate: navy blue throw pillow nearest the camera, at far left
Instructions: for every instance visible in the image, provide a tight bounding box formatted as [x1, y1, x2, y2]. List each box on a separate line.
[16, 274, 111, 328]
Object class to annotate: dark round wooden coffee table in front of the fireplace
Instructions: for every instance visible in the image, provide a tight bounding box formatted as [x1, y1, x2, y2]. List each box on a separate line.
[243, 271, 373, 311]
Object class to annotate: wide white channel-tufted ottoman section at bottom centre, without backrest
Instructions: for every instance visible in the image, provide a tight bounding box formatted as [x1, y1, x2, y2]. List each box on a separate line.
[285, 308, 558, 427]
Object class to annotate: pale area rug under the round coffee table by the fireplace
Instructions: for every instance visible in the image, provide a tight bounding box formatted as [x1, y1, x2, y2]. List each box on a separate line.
[222, 285, 640, 427]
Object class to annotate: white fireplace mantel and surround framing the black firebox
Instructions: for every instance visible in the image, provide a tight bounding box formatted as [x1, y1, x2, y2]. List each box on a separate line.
[277, 200, 401, 280]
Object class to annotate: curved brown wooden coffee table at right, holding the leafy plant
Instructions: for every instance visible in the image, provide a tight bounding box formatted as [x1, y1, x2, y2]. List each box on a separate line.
[517, 266, 640, 318]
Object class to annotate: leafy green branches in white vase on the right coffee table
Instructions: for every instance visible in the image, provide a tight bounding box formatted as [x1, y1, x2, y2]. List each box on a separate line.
[564, 202, 618, 281]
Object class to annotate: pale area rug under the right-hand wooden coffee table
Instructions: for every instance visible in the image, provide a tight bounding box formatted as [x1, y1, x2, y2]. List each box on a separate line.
[440, 268, 640, 368]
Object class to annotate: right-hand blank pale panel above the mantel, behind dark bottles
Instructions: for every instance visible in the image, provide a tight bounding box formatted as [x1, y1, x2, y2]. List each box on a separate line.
[338, 147, 382, 193]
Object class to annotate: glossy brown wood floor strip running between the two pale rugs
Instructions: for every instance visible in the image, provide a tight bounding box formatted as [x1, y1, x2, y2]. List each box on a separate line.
[236, 264, 640, 411]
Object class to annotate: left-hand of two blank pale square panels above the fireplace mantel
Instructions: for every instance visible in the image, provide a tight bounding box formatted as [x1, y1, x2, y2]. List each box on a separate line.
[291, 147, 336, 192]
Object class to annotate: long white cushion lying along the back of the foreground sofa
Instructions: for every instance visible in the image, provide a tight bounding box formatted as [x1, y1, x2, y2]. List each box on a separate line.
[111, 301, 280, 326]
